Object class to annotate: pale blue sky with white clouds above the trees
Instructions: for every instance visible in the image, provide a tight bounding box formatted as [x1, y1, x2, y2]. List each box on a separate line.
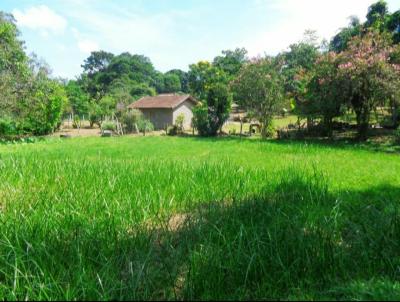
[0, 0, 400, 79]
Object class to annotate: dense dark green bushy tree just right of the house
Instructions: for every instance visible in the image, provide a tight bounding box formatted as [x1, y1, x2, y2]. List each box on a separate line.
[193, 83, 232, 136]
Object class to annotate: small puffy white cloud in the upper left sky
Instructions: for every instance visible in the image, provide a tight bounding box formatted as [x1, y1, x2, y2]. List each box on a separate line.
[12, 5, 68, 37]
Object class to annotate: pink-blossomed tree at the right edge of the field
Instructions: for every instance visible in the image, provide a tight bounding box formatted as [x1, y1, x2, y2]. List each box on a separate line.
[339, 31, 400, 139]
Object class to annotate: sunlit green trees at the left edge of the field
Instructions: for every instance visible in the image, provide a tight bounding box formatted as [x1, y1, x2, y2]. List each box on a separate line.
[0, 12, 68, 136]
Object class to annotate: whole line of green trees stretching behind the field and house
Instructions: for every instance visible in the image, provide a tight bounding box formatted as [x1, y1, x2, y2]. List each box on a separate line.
[0, 1, 400, 138]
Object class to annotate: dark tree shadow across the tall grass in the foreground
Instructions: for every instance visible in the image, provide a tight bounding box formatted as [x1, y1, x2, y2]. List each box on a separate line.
[0, 171, 400, 300]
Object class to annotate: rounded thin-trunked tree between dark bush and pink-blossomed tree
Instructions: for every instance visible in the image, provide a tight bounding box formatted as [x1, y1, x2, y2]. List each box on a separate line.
[232, 57, 284, 138]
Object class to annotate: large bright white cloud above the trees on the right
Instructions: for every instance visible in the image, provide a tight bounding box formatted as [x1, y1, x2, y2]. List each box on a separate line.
[246, 0, 374, 55]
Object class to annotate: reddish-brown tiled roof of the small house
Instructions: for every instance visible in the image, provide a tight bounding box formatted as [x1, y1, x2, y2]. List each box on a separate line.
[128, 94, 197, 109]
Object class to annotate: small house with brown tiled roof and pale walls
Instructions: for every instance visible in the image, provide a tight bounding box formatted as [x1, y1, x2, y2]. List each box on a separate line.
[128, 94, 198, 130]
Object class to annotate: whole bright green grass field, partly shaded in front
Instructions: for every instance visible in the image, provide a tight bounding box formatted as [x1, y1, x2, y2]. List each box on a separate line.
[0, 137, 400, 300]
